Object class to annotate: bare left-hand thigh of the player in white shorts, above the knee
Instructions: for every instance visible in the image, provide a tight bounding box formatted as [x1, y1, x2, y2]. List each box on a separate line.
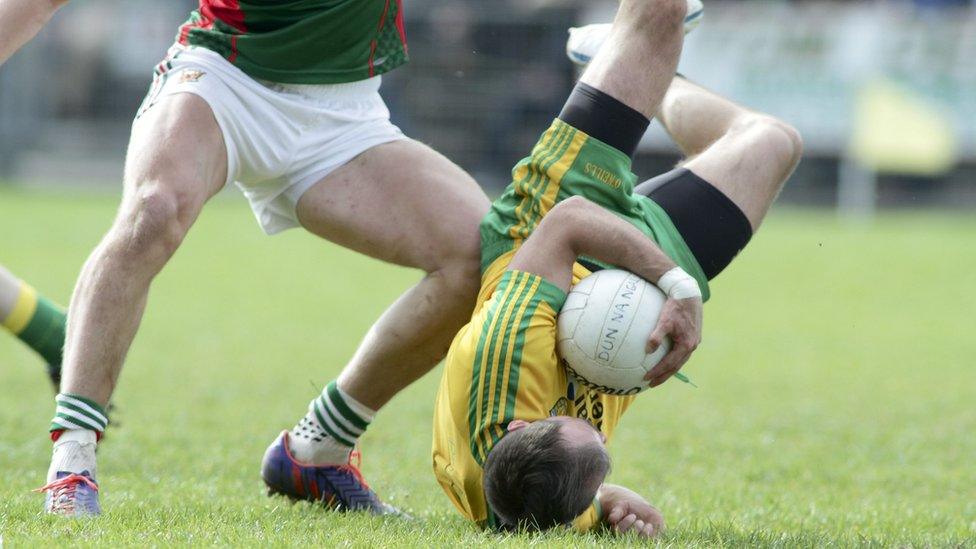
[120, 93, 227, 228]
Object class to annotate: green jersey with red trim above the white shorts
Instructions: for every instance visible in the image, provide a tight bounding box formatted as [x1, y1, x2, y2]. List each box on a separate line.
[177, 0, 407, 84]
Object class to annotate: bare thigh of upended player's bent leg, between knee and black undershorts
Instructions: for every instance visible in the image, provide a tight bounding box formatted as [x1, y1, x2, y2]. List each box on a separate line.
[684, 114, 801, 230]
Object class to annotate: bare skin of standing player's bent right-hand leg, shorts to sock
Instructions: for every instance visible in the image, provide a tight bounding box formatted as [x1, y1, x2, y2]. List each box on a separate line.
[297, 140, 489, 409]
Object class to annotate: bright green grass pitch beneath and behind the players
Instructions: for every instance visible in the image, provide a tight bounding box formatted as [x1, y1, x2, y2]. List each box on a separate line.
[0, 190, 976, 547]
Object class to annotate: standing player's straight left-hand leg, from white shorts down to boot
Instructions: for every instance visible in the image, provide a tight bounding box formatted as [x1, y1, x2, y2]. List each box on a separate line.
[39, 94, 227, 515]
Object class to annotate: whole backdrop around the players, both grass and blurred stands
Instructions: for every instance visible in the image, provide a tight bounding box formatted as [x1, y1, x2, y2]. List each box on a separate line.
[0, 4, 976, 548]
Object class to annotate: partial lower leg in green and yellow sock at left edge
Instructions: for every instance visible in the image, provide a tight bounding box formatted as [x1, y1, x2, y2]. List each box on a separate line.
[0, 266, 65, 391]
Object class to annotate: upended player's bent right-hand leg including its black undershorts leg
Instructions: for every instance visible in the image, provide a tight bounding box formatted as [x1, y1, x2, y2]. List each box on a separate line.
[635, 77, 803, 278]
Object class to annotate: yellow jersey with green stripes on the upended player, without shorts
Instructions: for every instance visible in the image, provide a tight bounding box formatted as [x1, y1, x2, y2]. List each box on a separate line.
[433, 252, 634, 531]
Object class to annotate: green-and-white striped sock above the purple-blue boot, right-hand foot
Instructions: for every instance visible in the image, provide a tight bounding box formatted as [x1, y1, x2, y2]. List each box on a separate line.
[290, 381, 376, 465]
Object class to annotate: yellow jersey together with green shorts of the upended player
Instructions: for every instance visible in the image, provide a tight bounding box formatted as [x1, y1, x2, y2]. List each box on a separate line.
[433, 116, 708, 530]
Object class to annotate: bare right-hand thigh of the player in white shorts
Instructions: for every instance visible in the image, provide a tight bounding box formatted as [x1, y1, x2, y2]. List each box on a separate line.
[296, 139, 489, 272]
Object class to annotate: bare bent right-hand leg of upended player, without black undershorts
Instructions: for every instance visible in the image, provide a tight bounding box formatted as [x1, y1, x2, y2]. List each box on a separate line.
[637, 77, 803, 231]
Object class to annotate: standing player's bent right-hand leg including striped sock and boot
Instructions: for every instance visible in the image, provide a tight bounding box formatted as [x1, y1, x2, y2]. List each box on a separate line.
[262, 140, 488, 514]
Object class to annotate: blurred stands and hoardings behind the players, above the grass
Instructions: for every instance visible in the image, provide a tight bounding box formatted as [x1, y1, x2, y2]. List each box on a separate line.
[0, 0, 976, 217]
